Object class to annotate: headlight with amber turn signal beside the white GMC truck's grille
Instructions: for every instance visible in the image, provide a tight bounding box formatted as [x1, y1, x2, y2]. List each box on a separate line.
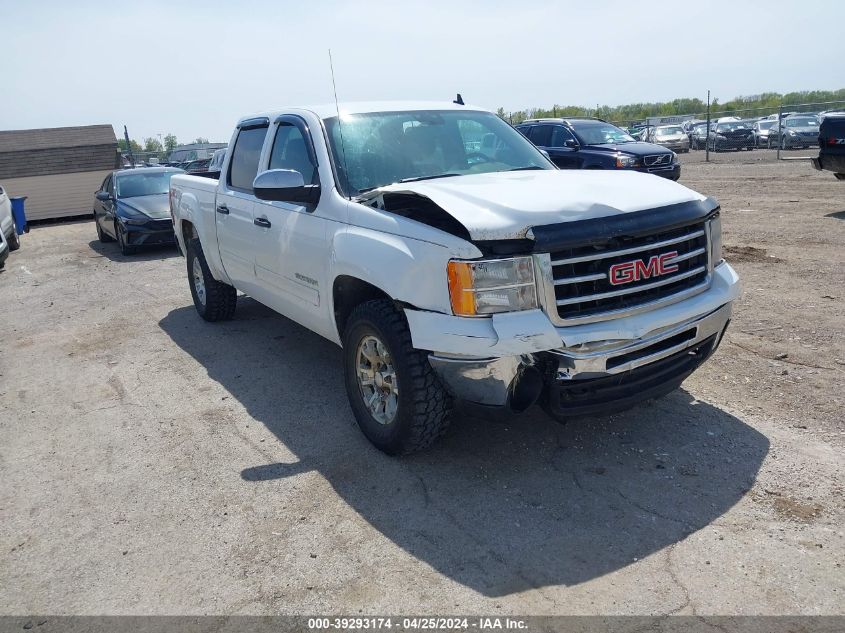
[448, 257, 537, 316]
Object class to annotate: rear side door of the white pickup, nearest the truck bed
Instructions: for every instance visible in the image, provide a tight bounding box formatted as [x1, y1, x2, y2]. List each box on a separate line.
[214, 118, 269, 294]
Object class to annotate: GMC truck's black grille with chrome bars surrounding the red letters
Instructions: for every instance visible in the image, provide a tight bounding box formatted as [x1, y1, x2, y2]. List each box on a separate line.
[551, 222, 709, 320]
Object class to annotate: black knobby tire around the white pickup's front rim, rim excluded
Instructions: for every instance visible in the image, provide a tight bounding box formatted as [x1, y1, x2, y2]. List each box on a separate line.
[343, 299, 452, 455]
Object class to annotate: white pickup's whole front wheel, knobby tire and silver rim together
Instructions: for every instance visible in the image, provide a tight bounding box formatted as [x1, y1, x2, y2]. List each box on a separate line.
[343, 300, 452, 455]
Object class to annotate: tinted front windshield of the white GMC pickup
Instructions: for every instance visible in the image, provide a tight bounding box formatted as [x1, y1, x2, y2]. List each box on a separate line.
[325, 110, 554, 195]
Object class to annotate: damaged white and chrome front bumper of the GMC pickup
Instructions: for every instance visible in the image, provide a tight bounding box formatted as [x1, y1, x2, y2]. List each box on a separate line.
[406, 263, 739, 415]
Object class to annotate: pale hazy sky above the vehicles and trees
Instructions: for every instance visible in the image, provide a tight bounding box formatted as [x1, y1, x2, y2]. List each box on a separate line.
[0, 0, 845, 142]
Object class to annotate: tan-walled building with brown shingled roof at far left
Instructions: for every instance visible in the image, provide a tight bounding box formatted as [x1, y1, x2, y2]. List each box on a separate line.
[0, 125, 120, 220]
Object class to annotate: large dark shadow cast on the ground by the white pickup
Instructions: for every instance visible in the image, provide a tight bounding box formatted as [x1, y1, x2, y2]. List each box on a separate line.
[155, 297, 769, 596]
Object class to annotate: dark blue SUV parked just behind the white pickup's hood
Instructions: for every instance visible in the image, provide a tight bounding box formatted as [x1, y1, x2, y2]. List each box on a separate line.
[516, 118, 681, 180]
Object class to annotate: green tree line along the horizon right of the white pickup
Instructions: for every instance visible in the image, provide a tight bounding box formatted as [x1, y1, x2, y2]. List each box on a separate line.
[497, 88, 845, 125]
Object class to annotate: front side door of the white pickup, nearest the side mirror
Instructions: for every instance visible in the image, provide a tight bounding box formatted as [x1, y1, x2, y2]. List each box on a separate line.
[253, 115, 329, 329]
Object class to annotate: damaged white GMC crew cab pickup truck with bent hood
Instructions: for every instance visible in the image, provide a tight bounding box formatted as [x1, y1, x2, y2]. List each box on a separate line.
[170, 102, 739, 454]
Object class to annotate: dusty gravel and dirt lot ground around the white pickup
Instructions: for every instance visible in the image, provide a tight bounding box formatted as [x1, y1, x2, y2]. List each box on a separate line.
[0, 151, 845, 614]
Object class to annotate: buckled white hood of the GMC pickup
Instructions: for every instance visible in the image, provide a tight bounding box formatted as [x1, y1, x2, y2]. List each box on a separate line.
[361, 170, 706, 241]
